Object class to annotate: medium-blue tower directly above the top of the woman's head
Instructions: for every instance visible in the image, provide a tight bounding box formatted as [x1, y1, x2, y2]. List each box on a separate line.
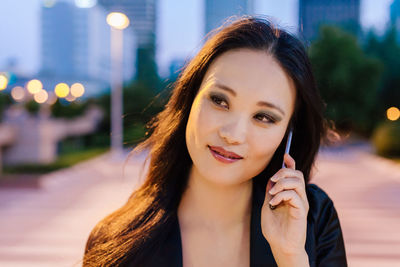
[205, 0, 254, 33]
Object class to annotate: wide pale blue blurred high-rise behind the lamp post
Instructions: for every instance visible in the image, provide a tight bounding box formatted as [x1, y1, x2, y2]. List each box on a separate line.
[39, 1, 136, 96]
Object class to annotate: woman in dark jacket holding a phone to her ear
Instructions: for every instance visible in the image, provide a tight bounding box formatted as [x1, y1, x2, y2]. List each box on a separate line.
[83, 17, 347, 267]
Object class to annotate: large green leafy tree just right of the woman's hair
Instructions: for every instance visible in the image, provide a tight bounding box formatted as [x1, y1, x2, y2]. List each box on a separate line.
[309, 26, 382, 135]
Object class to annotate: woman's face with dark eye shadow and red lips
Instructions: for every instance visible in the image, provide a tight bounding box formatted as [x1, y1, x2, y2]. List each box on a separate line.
[186, 49, 296, 185]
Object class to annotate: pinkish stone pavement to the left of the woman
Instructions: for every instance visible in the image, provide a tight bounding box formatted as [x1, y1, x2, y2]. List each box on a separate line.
[0, 151, 148, 267]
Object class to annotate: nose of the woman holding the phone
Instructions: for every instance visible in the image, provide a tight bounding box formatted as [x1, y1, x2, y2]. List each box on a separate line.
[219, 119, 247, 145]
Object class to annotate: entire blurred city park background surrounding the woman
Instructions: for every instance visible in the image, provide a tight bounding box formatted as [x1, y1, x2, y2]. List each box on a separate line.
[0, 0, 400, 266]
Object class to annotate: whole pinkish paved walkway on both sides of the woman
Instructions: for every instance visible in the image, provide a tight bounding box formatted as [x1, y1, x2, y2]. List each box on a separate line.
[0, 149, 400, 267]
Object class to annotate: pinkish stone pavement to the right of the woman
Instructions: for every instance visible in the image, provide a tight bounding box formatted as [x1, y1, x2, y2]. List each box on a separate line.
[311, 150, 400, 267]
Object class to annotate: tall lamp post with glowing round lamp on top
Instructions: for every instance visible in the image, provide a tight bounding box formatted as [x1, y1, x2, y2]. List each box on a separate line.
[107, 12, 129, 157]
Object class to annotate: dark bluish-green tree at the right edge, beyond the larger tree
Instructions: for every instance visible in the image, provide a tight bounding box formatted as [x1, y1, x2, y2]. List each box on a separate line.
[364, 28, 400, 108]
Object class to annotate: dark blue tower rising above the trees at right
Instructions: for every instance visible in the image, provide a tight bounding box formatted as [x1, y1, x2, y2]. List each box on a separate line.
[299, 0, 360, 40]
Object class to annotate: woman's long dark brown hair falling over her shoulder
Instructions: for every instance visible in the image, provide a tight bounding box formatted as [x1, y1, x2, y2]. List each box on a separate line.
[83, 16, 326, 266]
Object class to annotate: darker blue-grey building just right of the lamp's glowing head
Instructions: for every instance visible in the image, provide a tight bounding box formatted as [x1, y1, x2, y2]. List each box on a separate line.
[98, 0, 158, 80]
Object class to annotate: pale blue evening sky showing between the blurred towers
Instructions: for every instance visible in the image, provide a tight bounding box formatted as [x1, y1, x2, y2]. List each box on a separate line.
[0, 0, 393, 76]
